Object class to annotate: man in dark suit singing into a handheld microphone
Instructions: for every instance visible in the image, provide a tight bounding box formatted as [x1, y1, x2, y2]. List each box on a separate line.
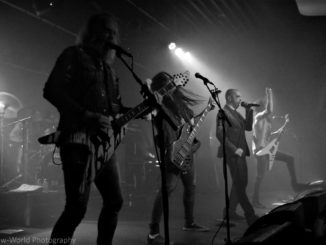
[216, 89, 258, 225]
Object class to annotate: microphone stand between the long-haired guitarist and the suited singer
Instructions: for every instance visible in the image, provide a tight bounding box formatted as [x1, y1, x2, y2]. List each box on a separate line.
[202, 78, 232, 245]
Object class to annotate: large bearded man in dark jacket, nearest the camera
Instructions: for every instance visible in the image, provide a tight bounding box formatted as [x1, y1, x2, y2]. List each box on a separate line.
[44, 13, 129, 245]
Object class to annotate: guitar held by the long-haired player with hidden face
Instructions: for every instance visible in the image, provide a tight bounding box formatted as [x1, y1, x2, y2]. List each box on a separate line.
[168, 98, 214, 171]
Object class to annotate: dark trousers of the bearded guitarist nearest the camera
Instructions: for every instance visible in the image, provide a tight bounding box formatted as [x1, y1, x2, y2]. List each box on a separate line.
[50, 144, 123, 245]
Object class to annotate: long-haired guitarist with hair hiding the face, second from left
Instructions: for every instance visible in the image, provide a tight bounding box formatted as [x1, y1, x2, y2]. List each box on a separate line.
[147, 72, 209, 244]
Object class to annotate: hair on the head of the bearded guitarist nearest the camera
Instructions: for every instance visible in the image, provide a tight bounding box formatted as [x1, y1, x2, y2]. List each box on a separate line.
[76, 12, 119, 46]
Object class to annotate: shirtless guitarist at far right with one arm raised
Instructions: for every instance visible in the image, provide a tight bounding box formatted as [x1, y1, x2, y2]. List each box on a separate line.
[252, 88, 306, 208]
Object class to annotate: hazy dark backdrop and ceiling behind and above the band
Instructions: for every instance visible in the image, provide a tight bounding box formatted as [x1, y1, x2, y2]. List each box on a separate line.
[0, 0, 326, 193]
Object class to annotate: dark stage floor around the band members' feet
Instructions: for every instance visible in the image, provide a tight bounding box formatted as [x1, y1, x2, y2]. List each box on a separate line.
[0, 185, 290, 245]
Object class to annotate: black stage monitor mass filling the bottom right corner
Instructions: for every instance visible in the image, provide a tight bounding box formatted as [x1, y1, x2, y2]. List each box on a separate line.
[235, 189, 326, 244]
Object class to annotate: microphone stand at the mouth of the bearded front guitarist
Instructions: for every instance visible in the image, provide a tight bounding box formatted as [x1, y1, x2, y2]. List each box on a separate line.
[117, 52, 170, 245]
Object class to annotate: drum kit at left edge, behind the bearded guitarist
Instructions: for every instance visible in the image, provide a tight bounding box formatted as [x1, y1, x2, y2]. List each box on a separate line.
[0, 92, 63, 190]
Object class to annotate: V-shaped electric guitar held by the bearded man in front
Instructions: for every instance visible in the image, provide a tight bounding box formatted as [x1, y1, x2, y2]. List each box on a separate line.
[38, 71, 190, 151]
